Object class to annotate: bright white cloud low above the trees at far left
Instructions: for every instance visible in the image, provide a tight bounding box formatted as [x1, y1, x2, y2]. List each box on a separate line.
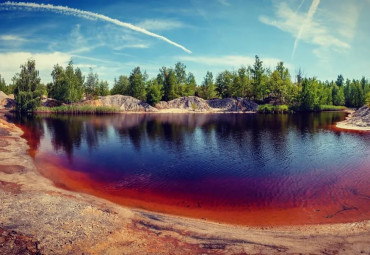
[0, 52, 72, 83]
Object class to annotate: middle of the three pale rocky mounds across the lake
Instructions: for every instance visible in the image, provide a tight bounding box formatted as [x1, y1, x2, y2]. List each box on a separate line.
[155, 96, 212, 112]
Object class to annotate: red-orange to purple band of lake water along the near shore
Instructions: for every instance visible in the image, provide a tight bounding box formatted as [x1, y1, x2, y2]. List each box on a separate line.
[14, 114, 370, 226]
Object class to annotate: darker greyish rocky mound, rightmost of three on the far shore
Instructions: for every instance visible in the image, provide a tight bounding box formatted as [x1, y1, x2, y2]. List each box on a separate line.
[207, 97, 258, 112]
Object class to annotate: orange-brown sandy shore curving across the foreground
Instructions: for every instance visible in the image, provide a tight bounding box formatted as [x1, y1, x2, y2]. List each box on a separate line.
[0, 113, 370, 254]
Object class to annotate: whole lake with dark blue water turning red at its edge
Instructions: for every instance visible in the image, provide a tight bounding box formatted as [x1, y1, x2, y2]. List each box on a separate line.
[9, 112, 370, 225]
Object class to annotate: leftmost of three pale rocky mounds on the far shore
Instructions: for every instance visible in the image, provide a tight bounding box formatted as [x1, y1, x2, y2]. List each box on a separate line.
[83, 95, 157, 112]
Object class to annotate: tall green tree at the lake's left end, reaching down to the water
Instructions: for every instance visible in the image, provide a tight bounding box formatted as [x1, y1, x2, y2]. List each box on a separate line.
[13, 59, 42, 112]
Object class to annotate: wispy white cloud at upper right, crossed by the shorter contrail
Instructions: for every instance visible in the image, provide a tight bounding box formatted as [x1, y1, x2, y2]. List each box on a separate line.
[259, 1, 355, 57]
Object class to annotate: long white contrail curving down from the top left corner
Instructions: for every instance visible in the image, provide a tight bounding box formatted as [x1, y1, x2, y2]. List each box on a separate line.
[0, 1, 191, 54]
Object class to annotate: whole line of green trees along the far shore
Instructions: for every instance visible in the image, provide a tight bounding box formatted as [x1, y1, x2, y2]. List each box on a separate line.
[0, 56, 370, 111]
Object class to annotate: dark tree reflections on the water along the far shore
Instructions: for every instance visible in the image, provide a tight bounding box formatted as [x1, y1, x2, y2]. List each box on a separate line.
[11, 112, 344, 161]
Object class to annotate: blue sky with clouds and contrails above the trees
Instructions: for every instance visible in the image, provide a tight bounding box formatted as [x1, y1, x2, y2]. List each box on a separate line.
[0, 0, 370, 86]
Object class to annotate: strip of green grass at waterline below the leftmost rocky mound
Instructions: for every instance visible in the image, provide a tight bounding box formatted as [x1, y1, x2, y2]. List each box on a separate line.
[36, 105, 120, 114]
